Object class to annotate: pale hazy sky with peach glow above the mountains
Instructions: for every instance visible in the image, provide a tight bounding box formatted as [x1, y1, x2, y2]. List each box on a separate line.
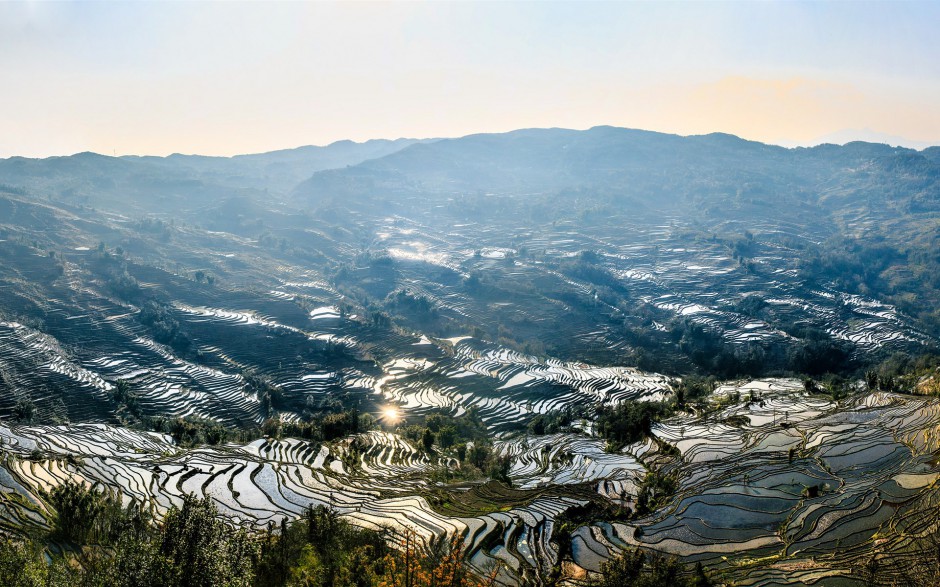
[0, 2, 940, 156]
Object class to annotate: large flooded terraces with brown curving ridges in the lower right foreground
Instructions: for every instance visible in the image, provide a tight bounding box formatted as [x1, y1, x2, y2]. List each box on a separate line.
[574, 385, 940, 585]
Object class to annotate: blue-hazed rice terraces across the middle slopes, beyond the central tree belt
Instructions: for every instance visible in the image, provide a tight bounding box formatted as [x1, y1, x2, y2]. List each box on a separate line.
[0, 198, 934, 428]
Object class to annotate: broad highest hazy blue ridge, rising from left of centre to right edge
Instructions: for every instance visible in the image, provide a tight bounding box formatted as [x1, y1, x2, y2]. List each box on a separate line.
[293, 127, 940, 223]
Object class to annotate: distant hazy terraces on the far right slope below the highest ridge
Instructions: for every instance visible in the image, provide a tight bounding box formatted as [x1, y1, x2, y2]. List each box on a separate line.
[366, 212, 930, 363]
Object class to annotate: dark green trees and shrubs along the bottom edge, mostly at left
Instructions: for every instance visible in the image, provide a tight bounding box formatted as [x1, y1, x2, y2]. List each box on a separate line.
[0, 482, 711, 587]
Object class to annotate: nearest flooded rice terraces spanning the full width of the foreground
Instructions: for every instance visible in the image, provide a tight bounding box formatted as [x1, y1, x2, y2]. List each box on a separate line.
[0, 380, 940, 585]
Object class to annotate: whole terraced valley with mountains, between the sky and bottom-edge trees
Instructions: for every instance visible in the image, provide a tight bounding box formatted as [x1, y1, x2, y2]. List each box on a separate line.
[0, 127, 940, 586]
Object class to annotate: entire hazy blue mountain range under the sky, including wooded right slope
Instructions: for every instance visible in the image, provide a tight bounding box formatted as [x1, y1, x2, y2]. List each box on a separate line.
[0, 126, 940, 342]
